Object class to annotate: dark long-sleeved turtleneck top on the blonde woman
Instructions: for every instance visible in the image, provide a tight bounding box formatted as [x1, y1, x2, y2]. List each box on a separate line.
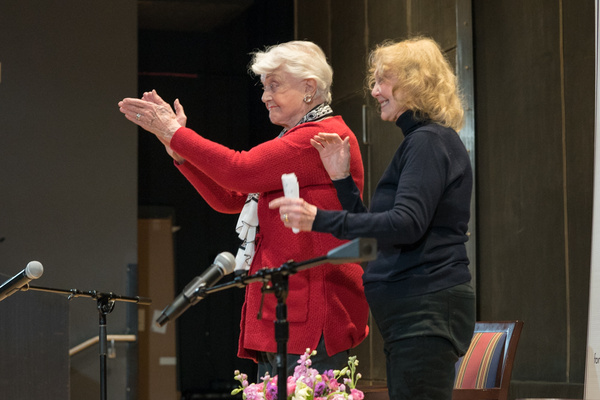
[313, 111, 473, 296]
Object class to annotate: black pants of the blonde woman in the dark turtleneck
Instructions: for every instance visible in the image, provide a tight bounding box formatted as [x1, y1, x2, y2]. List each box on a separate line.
[367, 284, 475, 400]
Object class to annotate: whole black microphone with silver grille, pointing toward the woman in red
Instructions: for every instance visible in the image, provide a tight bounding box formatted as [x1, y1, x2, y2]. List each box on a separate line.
[156, 251, 235, 326]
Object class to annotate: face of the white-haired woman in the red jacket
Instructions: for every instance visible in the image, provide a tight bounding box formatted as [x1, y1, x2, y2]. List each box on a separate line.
[261, 68, 315, 129]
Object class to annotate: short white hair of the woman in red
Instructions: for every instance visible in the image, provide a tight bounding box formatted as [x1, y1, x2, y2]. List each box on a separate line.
[250, 40, 333, 104]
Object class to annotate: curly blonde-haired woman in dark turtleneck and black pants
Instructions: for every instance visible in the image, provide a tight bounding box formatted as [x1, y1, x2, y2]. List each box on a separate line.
[269, 38, 475, 400]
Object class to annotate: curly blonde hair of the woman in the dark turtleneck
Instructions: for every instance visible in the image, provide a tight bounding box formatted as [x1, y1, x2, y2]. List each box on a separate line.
[368, 37, 464, 132]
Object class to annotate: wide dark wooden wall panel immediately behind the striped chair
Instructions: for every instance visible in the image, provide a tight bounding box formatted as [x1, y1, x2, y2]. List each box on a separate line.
[474, 2, 566, 381]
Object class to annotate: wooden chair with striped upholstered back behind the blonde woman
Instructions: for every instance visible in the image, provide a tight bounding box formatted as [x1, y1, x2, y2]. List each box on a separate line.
[452, 321, 523, 400]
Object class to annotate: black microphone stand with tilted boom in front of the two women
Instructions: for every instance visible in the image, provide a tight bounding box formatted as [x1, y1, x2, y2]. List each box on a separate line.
[195, 238, 377, 399]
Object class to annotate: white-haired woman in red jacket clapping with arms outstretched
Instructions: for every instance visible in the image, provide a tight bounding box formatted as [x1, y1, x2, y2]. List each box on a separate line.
[119, 41, 368, 376]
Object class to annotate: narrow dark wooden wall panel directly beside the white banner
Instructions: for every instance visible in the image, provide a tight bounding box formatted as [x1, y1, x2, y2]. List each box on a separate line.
[562, 1, 595, 383]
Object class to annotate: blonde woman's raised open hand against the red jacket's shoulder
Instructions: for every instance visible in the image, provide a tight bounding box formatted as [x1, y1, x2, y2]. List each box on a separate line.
[310, 132, 350, 180]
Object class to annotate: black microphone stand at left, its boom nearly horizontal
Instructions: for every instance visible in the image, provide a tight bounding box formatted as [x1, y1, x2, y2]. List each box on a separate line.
[21, 285, 152, 400]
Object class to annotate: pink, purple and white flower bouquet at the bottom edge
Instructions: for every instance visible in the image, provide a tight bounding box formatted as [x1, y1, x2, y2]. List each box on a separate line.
[231, 349, 365, 400]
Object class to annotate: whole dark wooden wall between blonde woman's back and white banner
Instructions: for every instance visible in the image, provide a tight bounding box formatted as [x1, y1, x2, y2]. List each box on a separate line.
[473, 1, 595, 397]
